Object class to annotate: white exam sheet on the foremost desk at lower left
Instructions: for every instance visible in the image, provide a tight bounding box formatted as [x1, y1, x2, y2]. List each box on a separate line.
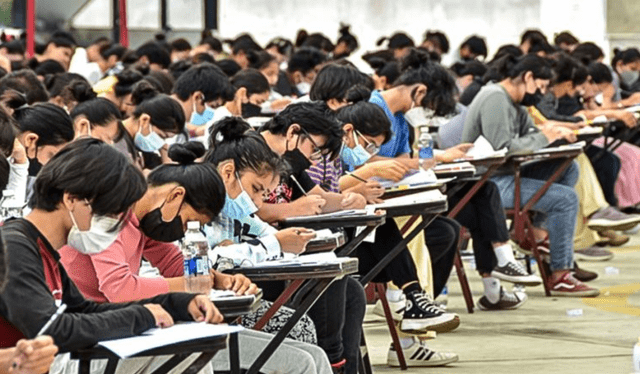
[98, 322, 243, 358]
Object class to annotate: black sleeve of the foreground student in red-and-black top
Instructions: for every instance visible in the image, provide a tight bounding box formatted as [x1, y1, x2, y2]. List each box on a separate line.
[0, 237, 155, 352]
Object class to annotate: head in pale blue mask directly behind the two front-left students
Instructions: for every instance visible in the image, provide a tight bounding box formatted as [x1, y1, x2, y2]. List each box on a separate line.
[122, 81, 185, 169]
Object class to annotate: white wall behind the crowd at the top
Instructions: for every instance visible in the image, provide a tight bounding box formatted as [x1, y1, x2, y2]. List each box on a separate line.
[74, 0, 608, 62]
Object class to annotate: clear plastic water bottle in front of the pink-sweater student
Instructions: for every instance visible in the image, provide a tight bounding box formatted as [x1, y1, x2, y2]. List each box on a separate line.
[181, 221, 213, 295]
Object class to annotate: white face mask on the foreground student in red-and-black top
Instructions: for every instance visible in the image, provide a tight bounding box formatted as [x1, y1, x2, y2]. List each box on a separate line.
[67, 211, 120, 255]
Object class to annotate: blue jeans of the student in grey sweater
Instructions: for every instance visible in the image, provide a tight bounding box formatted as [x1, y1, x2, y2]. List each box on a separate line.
[491, 161, 579, 271]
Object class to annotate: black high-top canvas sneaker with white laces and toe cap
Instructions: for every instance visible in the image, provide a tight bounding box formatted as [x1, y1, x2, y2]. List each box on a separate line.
[400, 291, 460, 334]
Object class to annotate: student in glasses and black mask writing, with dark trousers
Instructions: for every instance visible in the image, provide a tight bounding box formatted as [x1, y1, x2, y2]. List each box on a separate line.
[257, 102, 366, 373]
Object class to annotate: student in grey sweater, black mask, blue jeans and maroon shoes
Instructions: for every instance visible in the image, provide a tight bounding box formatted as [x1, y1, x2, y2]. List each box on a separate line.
[462, 55, 599, 297]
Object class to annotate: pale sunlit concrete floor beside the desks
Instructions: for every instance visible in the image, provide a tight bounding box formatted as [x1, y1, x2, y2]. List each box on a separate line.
[365, 234, 640, 374]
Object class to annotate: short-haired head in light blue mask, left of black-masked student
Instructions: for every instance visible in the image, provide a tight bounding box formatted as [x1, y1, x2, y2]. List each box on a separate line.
[171, 63, 235, 136]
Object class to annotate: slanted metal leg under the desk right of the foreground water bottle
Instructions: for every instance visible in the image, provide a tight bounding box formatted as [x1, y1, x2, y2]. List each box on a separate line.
[247, 278, 334, 374]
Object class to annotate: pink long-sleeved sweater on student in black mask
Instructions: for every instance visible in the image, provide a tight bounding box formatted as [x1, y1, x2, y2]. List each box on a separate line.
[59, 214, 184, 303]
